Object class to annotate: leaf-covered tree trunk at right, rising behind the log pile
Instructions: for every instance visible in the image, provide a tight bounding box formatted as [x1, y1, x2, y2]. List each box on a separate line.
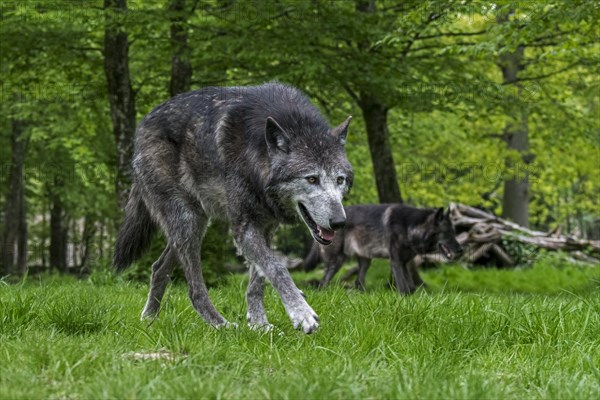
[497, 12, 533, 227]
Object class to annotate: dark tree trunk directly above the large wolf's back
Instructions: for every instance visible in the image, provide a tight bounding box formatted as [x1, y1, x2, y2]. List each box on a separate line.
[169, 0, 192, 96]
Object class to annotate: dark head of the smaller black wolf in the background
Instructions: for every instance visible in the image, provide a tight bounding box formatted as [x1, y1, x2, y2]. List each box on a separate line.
[418, 208, 463, 260]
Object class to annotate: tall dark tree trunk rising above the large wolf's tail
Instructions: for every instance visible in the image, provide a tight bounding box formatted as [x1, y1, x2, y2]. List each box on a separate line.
[104, 0, 135, 208]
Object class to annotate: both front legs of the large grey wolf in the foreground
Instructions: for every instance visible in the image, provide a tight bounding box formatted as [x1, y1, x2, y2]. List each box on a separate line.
[233, 225, 319, 333]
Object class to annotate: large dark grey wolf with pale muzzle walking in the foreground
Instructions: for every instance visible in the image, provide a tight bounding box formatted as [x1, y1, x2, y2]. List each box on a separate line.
[113, 83, 353, 333]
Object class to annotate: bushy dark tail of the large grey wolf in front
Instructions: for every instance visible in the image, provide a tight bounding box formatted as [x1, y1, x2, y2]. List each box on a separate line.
[113, 184, 156, 271]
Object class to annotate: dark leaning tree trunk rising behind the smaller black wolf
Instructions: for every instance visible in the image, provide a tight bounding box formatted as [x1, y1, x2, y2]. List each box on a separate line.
[359, 93, 402, 203]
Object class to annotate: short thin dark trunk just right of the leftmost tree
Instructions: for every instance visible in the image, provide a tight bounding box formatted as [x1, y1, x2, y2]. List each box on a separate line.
[50, 185, 68, 273]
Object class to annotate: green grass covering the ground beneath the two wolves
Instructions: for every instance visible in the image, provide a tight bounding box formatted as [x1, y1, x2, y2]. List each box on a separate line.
[0, 262, 600, 399]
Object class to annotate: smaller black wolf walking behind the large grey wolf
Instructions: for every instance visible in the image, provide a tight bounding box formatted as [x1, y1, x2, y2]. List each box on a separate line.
[304, 204, 462, 294]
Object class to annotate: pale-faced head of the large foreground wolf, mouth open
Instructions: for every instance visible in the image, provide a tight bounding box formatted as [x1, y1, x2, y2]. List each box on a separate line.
[265, 117, 353, 245]
